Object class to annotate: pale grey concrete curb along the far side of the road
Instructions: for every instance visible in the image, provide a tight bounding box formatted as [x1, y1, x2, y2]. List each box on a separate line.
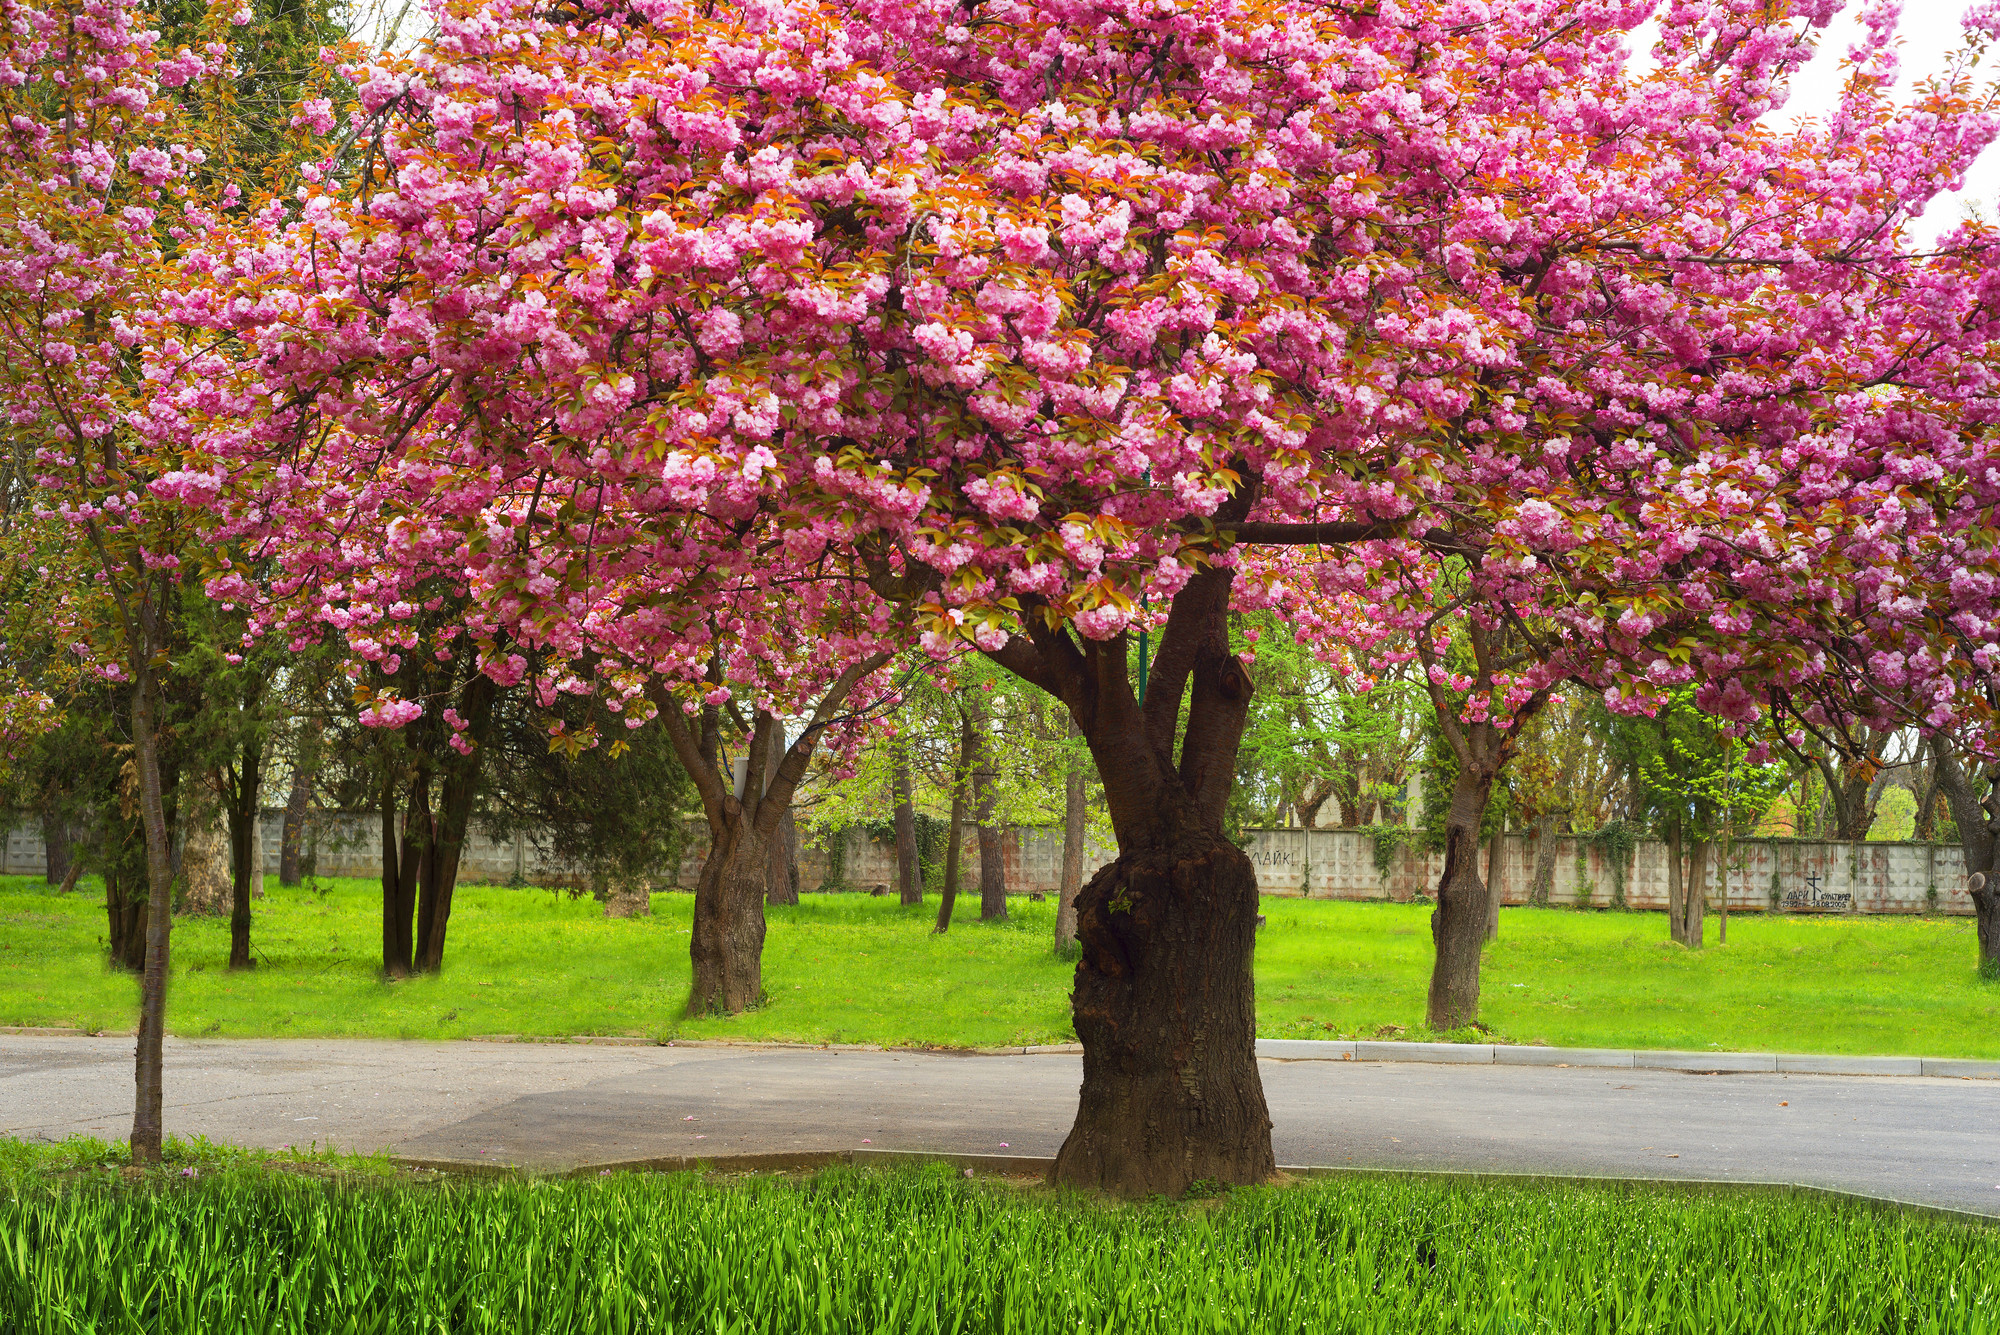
[1256, 1039, 2000, 1079]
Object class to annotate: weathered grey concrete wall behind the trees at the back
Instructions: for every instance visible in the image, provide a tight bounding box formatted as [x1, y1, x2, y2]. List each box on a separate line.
[0, 811, 1972, 913]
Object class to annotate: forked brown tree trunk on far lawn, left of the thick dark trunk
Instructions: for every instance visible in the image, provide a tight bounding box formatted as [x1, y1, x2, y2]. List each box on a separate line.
[650, 654, 888, 1015]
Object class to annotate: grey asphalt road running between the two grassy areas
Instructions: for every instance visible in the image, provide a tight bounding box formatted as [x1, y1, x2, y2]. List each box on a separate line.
[0, 1037, 2000, 1215]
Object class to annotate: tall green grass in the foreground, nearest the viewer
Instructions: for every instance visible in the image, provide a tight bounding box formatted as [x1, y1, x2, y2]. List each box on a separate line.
[0, 1167, 2000, 1335]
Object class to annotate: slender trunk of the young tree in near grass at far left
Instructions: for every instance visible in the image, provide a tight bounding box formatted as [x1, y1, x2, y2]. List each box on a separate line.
[132, 663, 174, 1163]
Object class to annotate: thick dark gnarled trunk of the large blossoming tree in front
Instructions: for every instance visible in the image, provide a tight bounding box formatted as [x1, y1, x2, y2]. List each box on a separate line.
[976, 568, 1276, 1197]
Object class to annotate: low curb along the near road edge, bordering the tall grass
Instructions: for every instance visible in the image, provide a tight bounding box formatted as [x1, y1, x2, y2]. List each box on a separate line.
[388, 1149, 2000, 1229]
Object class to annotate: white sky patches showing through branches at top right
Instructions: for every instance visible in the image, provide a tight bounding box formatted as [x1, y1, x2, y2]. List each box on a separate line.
[1632, 0, 2000, 242]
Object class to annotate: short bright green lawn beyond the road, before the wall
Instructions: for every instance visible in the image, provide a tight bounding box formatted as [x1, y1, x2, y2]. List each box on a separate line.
[0, 877, 2000, 1057]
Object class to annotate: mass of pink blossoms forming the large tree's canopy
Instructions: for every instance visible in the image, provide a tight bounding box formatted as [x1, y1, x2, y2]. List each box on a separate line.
[0, 0, 2000, 759]
